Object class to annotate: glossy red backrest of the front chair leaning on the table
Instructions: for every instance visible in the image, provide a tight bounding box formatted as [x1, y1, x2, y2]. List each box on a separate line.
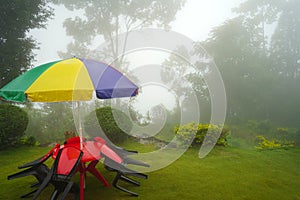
[53, 146, 83, 179]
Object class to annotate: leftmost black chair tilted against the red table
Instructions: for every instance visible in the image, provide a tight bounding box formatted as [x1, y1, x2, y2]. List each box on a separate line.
[7, 144, 60, 198]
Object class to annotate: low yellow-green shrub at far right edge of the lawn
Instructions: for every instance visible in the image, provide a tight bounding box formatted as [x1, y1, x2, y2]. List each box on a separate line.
[255, 135, 294, 150]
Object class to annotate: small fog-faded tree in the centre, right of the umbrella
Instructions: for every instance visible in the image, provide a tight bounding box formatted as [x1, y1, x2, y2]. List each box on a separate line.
[161, 46, 211, 124]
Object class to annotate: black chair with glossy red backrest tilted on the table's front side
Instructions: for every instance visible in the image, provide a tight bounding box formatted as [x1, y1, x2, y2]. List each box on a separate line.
[33, 146, 83, 200]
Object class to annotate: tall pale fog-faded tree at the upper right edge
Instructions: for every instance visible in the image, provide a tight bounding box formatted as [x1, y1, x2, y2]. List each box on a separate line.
[271, 0, 300, 78]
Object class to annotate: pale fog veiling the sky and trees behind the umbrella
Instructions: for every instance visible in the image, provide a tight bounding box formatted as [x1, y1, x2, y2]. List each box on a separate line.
[0, 0, 300, 147]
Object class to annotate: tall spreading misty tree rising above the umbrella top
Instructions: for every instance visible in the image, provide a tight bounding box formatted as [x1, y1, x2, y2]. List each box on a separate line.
[55, 0, 185, 67]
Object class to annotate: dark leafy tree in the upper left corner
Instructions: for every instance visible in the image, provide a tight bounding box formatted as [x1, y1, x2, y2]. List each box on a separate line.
[0, 0, 52, 88]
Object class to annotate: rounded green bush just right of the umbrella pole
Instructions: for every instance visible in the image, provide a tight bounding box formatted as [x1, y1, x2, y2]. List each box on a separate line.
[84, 107, 132, 143]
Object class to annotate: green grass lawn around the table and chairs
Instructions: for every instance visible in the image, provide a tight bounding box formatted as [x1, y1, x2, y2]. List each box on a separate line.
[0, 143, 300, 200]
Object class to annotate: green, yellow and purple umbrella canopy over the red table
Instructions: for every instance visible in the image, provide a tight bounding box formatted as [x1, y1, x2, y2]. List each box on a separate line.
[0, 58, 138, 102]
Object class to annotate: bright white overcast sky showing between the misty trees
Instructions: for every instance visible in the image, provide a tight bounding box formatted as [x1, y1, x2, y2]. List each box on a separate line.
[27, 0, 243, 113]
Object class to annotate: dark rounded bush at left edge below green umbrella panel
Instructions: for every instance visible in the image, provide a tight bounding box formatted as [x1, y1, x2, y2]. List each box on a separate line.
[0, 104, 28, 149]
